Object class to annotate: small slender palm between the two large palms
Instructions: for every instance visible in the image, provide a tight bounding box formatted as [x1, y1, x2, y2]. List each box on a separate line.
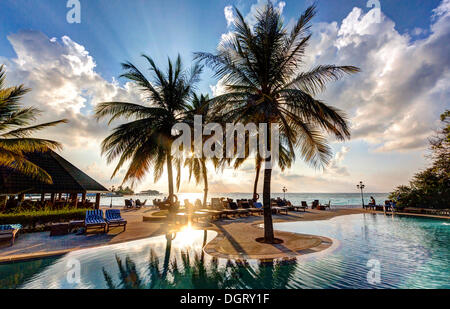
[184, 94, 213, 207]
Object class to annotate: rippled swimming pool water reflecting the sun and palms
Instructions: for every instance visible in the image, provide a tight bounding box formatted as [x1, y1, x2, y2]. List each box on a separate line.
[0, 214, 450, 289]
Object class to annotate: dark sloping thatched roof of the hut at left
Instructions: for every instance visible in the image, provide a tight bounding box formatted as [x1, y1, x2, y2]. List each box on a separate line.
[0, 151, 108, 194]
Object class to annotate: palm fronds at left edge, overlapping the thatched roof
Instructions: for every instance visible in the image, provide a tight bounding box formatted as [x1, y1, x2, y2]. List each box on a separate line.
[0, 65, 67, 205]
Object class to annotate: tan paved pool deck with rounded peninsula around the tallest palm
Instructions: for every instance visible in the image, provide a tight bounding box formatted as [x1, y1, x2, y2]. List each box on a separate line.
[0, 207, 449, 264]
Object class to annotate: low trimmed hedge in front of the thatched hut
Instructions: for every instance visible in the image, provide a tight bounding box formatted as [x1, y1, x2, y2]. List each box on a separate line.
[0, 209, 88, 229]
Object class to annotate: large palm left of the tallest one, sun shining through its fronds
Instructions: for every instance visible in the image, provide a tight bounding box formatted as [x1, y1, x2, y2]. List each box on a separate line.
[96, 55, 202, 206]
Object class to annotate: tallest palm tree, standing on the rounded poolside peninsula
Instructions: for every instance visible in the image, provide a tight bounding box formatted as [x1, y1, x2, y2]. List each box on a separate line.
[196, 1, 359, 243]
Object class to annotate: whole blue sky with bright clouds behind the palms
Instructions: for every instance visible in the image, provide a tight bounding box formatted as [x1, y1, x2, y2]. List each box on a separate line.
[0, 0, 450, 192]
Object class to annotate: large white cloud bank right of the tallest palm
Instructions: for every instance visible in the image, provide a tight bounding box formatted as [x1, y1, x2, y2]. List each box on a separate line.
[211, 0, 450, 152]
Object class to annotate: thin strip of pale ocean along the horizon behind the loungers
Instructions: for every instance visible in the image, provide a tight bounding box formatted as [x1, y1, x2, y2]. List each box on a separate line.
[100, 193, 389, 207]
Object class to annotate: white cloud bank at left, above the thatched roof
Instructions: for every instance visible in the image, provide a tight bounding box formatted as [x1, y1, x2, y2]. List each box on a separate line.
[0, 31, 140, 185]
